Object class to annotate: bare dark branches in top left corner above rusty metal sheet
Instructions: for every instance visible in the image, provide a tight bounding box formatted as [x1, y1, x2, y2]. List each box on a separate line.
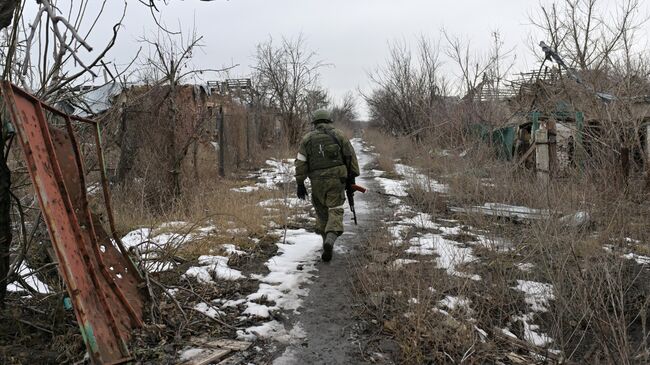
[0, 0, 127, 102]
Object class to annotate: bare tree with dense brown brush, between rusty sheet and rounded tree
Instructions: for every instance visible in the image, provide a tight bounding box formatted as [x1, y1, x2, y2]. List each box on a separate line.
[116, 31, 236, 200]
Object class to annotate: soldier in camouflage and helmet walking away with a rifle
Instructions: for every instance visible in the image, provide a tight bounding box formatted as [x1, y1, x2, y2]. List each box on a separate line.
[296, 109, 359, 262]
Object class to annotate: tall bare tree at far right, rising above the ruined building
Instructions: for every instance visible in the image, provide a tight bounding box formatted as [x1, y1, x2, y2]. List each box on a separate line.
[531, 0, 650, 187]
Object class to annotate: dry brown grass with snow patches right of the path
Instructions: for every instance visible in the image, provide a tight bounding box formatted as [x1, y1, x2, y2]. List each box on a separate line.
[358, 126, 650, 364]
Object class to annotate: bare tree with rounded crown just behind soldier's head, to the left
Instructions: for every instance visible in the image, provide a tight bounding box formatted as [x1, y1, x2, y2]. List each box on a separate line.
[253, 35, 325, 144]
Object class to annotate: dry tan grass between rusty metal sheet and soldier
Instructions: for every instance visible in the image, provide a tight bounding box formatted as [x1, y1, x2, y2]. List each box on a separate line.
[113, 149, 293, 259]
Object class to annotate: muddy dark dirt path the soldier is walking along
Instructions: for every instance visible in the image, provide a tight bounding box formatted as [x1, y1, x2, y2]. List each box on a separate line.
[273, 140, 384, 365]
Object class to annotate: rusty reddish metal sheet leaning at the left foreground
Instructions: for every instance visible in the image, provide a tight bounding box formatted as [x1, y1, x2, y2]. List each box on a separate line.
[2, 82, 143, 364]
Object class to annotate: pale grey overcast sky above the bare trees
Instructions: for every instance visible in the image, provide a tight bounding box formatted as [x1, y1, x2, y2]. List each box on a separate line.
[26, 0, 650, 118]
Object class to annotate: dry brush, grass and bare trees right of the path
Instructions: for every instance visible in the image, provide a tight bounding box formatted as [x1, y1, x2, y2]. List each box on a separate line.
[356, 0, 650, 364]
